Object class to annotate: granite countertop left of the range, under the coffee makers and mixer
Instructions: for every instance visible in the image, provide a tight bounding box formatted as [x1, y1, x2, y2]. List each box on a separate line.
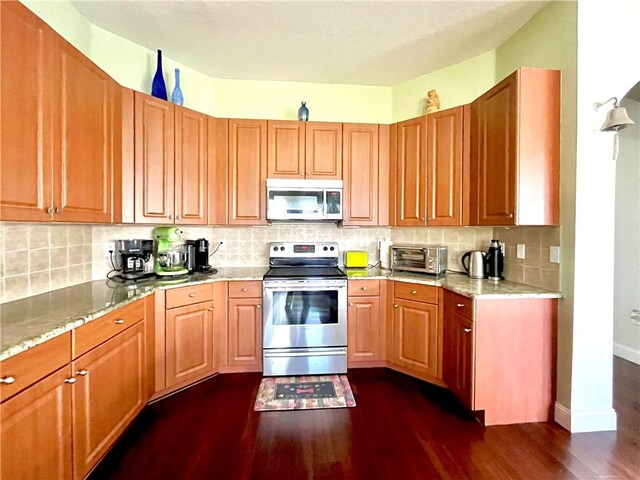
[0, 267, 267, 361]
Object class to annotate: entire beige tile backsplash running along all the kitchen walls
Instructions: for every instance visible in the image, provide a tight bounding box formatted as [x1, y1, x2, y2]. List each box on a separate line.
[0, 223, 560, 303]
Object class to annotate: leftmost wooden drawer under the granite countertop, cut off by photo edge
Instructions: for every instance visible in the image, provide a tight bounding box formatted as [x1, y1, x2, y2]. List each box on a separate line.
[0, 332, 71, 401]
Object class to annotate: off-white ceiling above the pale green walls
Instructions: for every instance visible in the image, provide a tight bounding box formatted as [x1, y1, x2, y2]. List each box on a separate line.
[71, 0, 546, 86]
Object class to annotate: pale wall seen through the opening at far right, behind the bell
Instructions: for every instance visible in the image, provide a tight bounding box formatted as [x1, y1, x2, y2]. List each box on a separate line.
[613, 99, 640, 364]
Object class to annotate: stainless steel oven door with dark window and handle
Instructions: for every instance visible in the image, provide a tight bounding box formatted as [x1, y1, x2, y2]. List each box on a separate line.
[263, 280, 347, 349]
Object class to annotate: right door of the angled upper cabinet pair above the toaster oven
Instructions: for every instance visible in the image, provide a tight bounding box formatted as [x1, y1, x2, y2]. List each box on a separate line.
[427, 107, 463, 225]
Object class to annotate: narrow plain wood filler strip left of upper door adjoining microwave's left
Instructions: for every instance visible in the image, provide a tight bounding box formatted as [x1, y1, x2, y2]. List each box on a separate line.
[207, 117, 229, 225]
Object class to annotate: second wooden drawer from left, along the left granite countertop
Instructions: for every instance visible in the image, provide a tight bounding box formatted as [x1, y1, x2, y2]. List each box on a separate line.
[73, 300, 144, 358]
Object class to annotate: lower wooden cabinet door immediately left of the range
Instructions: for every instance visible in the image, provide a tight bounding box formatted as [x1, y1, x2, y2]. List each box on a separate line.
[227, 298, 262, 366]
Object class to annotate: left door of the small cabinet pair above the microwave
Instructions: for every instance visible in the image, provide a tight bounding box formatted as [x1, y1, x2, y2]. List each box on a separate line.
[267, 120, 305, 178]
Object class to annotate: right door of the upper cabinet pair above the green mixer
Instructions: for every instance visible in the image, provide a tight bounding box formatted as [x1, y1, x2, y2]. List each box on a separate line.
[174, 106, 209, 225]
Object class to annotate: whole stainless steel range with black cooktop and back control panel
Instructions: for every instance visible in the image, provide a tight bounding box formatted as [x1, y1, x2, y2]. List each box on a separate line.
[263, 242, 347, 376]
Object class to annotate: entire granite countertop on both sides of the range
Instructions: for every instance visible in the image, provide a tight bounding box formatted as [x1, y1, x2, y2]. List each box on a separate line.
[0, 267, 562, 361]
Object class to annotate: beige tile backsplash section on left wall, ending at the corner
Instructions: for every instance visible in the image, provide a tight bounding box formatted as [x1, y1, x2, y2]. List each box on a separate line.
[0, 223, 93, 302]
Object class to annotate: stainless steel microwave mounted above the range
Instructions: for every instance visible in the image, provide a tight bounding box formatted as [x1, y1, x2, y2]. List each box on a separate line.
[267, 178, 342, 222]
